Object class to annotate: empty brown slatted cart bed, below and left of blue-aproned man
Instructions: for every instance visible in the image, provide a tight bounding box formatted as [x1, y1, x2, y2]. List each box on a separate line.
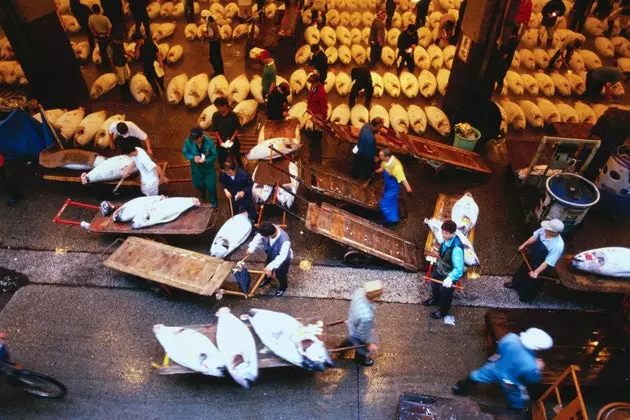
[305, 203, 419, 271]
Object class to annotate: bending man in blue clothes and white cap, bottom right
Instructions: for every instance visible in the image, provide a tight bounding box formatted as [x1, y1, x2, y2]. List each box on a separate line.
[452, 328, 553, 410]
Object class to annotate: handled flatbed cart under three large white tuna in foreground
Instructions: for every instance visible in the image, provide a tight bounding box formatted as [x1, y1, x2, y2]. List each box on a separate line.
[153, 316, 364, 375]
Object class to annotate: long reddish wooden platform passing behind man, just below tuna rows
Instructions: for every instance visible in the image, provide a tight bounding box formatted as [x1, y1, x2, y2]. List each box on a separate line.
[313, 118, 492, 174]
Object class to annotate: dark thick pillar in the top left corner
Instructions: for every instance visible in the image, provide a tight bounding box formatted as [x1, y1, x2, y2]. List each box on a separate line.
[0, 0, 89, 108]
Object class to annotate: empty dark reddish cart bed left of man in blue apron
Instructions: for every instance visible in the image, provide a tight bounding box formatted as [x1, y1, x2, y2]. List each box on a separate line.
[301, 163, 383, 210]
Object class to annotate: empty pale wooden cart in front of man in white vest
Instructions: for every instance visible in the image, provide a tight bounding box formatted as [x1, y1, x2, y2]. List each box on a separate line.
[103, 236, 264, 298]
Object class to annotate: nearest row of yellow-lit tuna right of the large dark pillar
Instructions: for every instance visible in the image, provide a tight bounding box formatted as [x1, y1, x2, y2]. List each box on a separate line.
[495, 98, 607, 131]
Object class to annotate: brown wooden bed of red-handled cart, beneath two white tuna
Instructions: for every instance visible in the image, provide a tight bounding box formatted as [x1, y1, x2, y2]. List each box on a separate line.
[90, 203, 218, 235]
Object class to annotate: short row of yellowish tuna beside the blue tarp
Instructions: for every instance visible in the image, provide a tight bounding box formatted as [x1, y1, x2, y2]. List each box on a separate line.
[35, 107, 125, 149]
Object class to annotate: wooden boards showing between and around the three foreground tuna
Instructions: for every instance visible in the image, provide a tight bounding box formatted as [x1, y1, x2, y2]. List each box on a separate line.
[158, 316, 327, 375]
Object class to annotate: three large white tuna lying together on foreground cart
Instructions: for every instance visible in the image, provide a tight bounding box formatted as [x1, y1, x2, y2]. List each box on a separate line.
[153, 307, 333, 388]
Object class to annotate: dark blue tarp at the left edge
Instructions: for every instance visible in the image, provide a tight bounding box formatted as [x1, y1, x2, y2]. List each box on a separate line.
[0, 109, 55, 159]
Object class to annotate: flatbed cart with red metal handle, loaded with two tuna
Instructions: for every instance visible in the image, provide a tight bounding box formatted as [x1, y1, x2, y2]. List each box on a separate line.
[53, 198, 218, 235]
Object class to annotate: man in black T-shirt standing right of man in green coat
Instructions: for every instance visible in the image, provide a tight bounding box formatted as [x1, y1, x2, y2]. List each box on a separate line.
[212, 98, 243, 168]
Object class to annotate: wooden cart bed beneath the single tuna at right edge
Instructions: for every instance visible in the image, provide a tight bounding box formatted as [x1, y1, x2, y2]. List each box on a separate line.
[555, 255, 630, 294]
